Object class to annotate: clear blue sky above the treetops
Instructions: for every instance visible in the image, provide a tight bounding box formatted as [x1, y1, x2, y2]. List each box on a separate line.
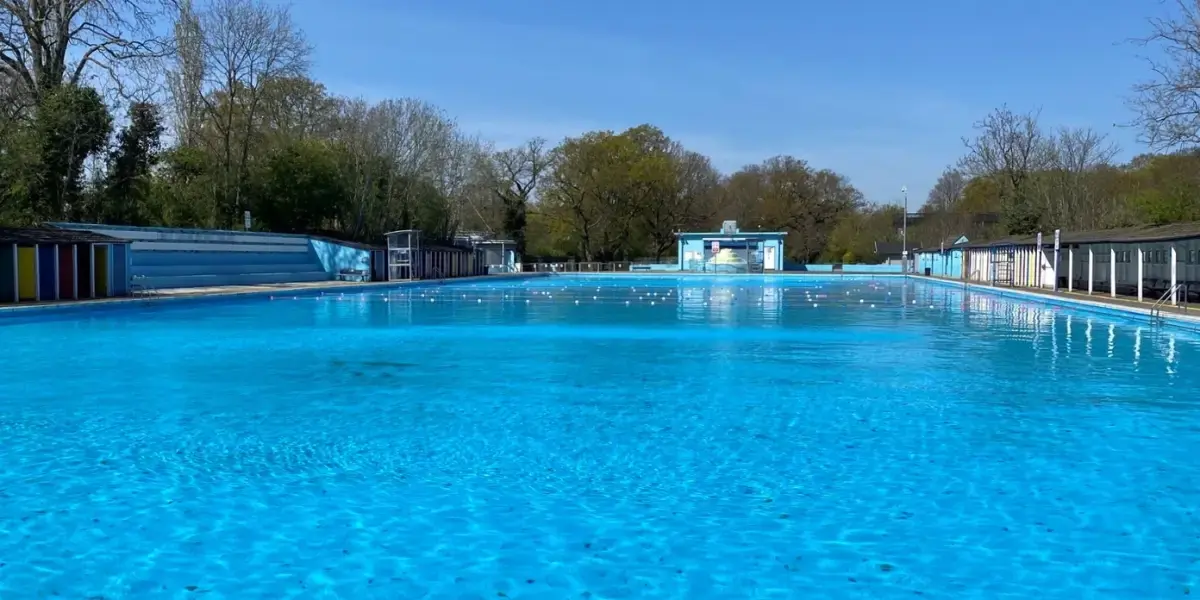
[293, 0, 1165, 205]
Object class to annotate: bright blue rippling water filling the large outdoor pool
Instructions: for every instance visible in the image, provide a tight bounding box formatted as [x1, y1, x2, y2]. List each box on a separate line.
[0, 277, 1200, 600]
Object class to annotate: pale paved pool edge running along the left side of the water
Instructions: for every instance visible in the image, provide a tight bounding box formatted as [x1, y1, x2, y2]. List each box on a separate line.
[0, 272, 547, 323]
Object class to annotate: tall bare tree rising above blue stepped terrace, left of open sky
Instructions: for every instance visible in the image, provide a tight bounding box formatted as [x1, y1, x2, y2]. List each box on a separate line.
[199, 0, 311, 217]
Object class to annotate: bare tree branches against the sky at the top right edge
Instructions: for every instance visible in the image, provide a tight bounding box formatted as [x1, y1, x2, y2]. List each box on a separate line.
[1129, 0, 1200, 150]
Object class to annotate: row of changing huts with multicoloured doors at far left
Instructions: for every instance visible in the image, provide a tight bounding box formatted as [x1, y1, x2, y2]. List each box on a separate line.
[0, 227, 132, 304]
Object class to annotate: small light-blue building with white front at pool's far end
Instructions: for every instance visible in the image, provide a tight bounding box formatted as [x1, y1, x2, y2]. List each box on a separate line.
[676, 221, 787, 272]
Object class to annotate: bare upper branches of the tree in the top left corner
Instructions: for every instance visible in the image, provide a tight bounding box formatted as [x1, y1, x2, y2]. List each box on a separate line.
[0, 0, 170, 102]
